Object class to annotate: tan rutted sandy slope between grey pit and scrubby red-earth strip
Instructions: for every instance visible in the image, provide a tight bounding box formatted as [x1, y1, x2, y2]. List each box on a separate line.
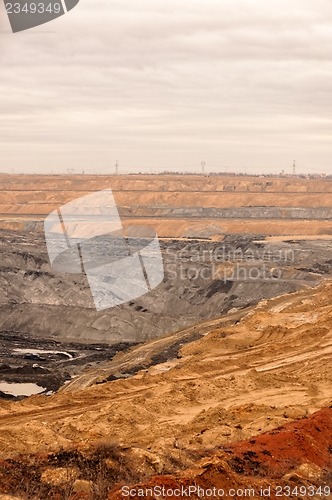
[0, 278, 332, 457]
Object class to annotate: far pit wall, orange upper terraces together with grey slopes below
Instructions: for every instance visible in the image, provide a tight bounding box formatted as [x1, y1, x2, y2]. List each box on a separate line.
[0, 175, 332, 346]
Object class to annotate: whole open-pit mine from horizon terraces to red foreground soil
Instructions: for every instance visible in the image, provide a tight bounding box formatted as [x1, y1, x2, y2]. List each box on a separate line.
[0, 174, 332, 500]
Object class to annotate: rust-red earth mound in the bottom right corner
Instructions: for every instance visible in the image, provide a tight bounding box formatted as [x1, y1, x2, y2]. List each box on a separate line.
[108, 408, 332, 500]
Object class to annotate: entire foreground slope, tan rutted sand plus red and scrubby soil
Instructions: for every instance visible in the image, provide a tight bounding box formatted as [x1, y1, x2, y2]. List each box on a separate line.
[0, 282, 332, 500]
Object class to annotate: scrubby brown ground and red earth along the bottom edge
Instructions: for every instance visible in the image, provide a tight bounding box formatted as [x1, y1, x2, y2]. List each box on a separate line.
[0, 408, 332, 500]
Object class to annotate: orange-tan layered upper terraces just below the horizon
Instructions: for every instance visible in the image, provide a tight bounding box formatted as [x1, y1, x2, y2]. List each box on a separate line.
[0, 174, 332, 238]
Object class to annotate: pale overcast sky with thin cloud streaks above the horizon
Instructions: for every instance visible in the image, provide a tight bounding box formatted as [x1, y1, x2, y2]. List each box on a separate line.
[0, 0, 332, 174]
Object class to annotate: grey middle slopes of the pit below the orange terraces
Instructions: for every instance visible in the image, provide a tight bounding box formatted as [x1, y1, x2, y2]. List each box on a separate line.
[0, 230, 332, 348]
